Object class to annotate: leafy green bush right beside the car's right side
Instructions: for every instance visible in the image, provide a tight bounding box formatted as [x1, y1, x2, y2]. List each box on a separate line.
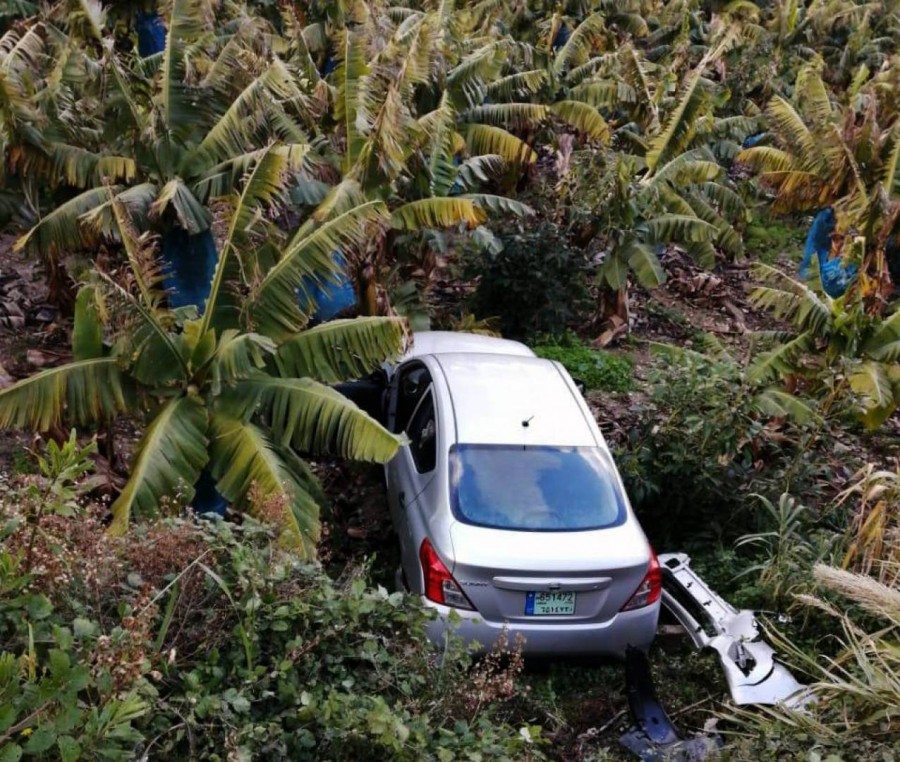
[617, 344, 822, 547]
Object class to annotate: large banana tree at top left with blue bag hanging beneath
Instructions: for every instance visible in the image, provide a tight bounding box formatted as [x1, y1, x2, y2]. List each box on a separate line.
[17, 0, 314, 307]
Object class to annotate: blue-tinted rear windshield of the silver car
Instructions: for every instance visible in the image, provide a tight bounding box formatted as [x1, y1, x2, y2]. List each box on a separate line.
[450, 444, 625, 531]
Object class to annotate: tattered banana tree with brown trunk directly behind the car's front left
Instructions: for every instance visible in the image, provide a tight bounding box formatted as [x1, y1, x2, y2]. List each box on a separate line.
[310, 11, 535, 314]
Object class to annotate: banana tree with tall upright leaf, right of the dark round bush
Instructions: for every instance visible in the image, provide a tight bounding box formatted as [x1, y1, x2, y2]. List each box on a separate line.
[595, 30, 750, 338]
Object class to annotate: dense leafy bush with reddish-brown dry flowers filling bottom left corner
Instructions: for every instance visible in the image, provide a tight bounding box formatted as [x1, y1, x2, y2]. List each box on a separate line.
[0, 486, 542, 762]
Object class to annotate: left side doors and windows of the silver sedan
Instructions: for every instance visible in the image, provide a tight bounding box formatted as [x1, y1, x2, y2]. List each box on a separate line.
[386, 363, 437, 587]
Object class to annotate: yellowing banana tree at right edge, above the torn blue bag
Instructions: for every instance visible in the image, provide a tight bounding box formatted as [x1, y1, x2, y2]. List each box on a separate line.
[738, 62, 900, 312]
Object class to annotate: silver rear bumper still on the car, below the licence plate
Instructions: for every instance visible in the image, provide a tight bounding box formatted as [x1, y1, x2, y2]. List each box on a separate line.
[424, 600, 659, 658]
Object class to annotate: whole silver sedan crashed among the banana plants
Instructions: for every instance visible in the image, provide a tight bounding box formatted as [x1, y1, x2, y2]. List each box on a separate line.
[374, 332, 662, 657]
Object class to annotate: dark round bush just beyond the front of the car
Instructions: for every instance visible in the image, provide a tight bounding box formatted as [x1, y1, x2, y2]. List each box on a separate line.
[470, 223, 587, 338]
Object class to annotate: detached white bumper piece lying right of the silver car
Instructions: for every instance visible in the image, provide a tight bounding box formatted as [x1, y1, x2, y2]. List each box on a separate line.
[659, 553, 811, 708]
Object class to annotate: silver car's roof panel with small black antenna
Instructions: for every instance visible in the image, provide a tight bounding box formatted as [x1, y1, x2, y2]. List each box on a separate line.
[435, 352, 598, 447]
